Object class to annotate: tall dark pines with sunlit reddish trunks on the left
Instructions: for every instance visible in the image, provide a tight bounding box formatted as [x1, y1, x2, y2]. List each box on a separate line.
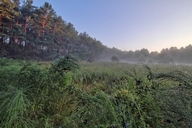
[0, 0, 105, 60]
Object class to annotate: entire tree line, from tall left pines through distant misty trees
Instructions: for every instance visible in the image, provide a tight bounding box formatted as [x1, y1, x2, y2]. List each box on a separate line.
[0, 0, 192, 63]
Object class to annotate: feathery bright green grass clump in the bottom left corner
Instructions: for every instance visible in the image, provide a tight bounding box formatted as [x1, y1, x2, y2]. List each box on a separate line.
[0, 86, 33, 128]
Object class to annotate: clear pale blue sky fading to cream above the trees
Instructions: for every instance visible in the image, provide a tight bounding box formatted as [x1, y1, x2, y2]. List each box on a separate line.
[33, 0, 192, 52]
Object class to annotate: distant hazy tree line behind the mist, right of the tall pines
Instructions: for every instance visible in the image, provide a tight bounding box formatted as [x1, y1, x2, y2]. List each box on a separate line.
[105, 44, 192, 64]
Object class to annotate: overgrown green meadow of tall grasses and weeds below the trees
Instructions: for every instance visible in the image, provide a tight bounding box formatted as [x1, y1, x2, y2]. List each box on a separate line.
[0, 56, 192, 128]
